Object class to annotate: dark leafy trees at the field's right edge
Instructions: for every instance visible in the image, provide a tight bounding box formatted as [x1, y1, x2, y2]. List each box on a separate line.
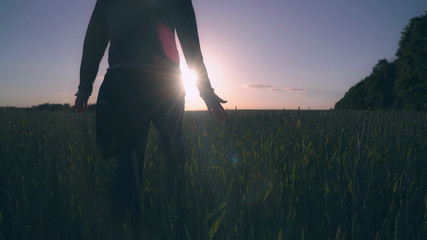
[335, 11, 427, 110]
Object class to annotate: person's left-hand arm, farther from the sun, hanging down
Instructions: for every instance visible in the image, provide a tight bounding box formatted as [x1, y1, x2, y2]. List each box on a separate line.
[76, 0, 109, 112]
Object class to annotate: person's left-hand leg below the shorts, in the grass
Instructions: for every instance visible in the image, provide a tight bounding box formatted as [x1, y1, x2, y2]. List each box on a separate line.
[112, 128, 149, 240]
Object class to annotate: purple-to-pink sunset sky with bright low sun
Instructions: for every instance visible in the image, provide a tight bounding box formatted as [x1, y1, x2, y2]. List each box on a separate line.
[0, 0, 427, 110]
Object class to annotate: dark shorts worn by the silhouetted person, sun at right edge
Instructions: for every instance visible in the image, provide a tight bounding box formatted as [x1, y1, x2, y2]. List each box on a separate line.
[96, 68, 185, 158]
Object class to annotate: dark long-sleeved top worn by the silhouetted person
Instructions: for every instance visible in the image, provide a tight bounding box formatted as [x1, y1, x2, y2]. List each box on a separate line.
[79, 0, 212, 94]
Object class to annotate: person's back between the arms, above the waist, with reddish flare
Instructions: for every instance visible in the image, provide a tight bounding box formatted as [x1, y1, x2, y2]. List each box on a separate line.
[106, 0, 179, 68]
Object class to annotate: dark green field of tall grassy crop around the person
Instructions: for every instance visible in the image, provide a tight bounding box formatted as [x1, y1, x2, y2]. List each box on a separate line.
[0, 109, 427, 240]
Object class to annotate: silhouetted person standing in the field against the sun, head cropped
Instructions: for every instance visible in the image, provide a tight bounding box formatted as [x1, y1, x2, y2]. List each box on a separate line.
[75, 0, 226, 239]
